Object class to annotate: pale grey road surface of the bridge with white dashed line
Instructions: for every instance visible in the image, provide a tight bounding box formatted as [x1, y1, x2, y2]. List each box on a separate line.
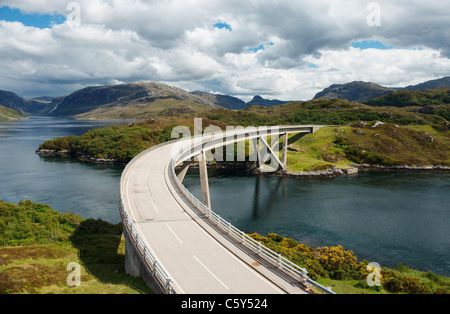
[121, 145, 306, 294]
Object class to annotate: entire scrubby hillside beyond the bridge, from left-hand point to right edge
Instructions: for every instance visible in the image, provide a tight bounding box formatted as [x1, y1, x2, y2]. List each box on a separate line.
[39, 99, 450, 171]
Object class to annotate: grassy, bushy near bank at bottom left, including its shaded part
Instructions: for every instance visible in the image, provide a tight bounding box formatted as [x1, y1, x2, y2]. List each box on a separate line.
[0, 201, 151, 294]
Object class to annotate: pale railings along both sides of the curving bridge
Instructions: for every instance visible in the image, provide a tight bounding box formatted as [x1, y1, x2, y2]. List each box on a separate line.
[119, 127, 334, 294]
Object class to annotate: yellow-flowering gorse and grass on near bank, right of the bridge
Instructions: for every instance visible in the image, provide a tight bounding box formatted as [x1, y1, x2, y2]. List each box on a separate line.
[250, 233, 450, 294]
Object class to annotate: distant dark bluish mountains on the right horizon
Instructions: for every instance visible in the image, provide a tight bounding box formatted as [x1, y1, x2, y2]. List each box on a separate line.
[314, 77, 450, 103]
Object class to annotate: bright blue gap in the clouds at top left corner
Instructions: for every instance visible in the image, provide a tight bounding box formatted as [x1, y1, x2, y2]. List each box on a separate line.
[0, 6, 66, 29]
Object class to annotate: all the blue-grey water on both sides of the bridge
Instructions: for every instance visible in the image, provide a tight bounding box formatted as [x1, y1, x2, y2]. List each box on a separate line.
[0, 117, 450, 276]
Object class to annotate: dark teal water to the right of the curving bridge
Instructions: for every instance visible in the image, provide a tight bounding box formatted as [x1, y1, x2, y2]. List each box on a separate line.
[184, 169, 450, 276]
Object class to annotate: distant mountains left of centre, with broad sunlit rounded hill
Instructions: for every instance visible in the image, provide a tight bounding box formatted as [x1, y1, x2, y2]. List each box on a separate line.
[0, 82, 292, 119]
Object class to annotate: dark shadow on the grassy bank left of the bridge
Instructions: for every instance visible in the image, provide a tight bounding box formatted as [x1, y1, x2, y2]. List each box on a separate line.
[70, 219, 152, 294]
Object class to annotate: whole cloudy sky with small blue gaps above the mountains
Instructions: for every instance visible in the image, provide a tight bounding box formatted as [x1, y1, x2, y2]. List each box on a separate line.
[0, 0, 450, 101]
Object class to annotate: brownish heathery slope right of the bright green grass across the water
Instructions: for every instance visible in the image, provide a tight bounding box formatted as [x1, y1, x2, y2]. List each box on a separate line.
[335, 122, 450, 166]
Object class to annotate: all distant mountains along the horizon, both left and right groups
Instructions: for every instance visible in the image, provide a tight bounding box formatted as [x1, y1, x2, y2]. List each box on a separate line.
[0, 77, 450, 120]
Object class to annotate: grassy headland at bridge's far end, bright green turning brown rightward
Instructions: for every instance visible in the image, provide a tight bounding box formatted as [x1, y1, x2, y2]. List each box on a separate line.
[287, 122, 450, 172]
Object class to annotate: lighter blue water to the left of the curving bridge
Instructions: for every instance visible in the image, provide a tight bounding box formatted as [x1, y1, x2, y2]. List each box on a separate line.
[0, 117, 126, 223]
